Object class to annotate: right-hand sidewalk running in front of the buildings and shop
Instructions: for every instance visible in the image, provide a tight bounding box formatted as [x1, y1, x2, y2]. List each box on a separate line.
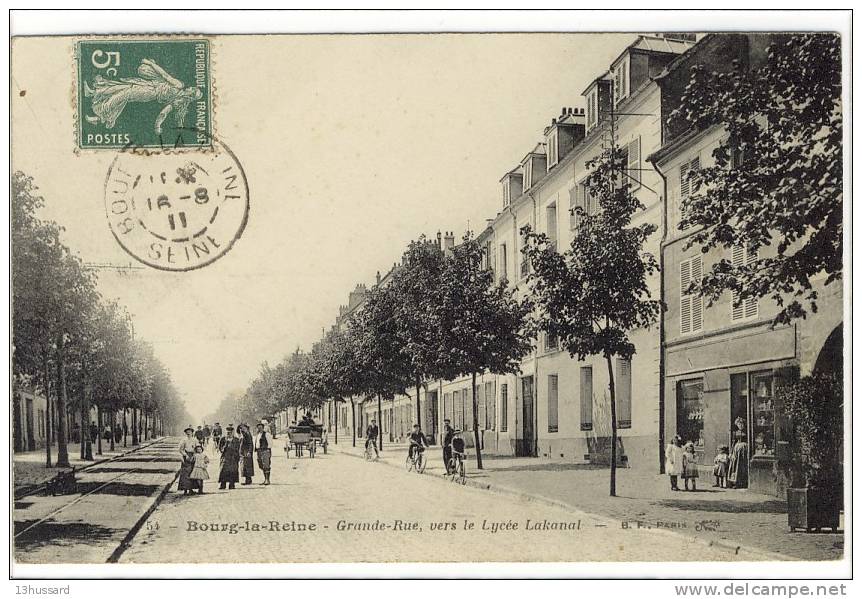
[330, 439, 844, 560]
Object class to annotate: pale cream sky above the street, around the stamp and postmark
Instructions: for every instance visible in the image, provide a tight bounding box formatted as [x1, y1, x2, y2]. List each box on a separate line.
[12, 34, 635, 419]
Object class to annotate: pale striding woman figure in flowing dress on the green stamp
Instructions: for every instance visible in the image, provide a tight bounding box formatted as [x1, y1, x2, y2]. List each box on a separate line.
[84, 58, 203, 135]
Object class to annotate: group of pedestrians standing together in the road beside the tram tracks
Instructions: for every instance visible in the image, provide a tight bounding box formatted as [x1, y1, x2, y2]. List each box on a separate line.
[177, 420, 272, 495]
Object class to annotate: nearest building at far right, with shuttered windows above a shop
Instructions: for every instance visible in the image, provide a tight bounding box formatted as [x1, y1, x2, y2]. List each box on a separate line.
[649, 34, 843, 496]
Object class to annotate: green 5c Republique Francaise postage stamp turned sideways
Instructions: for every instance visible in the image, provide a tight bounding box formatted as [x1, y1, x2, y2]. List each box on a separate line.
[77, 39, 212, 150]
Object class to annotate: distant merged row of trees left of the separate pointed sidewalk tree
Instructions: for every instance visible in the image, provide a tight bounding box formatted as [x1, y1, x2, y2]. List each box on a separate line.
[233, 233, 533, 468]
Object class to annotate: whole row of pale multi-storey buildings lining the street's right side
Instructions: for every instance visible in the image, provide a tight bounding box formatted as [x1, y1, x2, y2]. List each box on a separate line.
[296, 35, 843, 494]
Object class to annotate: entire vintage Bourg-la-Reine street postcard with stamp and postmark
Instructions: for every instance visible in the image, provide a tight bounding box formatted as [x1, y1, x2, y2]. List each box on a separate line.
[9, 13, 851, 578]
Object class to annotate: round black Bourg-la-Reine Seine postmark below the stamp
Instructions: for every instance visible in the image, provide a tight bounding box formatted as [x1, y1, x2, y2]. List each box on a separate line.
[105, 138, 249, 271]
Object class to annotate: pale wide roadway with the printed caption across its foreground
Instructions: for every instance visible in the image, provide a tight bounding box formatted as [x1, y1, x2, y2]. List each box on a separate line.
[120, 438, 748, 563]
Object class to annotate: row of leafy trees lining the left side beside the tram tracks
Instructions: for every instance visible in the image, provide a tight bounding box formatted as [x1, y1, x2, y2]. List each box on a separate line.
[11, 172, 188, 467]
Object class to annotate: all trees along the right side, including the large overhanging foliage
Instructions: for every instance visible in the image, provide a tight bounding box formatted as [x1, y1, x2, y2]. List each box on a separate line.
[231, 35, 843, 496]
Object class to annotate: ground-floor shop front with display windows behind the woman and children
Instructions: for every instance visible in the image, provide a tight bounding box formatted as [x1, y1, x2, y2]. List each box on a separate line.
[665, 328, 798, 497]
